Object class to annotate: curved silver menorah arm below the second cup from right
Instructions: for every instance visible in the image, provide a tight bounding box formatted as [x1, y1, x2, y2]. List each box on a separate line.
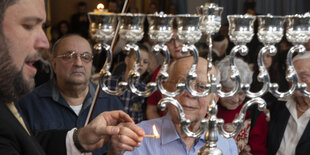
[242, 45, 277, 98]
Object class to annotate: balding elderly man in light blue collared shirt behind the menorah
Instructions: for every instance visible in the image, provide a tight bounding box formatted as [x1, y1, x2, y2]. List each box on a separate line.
[109, 57, 238, 155]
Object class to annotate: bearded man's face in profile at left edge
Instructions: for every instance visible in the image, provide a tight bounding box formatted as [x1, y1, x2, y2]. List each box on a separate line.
[1, 0, 49, 100]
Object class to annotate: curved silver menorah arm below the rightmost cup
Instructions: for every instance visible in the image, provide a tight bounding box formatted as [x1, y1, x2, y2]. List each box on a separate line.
[270, 45, 307, 98]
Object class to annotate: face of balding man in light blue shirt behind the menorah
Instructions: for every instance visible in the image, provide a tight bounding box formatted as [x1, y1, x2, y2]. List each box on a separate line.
[166, 58, 216, 123]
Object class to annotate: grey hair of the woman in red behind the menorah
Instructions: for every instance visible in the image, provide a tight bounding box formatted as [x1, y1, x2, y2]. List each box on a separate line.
[216, 56, 253, 88]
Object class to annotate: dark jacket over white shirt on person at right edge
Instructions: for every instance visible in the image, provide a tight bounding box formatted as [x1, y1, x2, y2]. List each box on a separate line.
[267, 102, 310, 155]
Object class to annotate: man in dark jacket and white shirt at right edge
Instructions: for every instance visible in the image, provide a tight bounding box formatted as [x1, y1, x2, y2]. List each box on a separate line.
[267, 51, 310, 155]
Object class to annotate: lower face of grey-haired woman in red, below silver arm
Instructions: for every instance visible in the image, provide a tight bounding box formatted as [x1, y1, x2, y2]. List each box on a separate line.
[219, 88, 245, 110]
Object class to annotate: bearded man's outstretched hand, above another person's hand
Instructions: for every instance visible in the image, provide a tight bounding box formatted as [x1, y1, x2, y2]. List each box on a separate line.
[78, 111, 144, 151]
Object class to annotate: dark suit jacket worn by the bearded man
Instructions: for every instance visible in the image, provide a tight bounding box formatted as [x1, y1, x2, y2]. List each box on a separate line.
[0, 98, 67, 155]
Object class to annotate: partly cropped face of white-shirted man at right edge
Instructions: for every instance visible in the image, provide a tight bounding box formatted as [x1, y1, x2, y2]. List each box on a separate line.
[293, 59, 310, 91]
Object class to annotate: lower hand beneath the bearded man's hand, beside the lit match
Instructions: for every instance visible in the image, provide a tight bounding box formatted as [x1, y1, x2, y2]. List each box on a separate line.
[108, 123, 144, 155]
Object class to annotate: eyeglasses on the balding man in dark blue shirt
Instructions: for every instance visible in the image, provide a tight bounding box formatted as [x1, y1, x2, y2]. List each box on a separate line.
[56, 51, 94, 63]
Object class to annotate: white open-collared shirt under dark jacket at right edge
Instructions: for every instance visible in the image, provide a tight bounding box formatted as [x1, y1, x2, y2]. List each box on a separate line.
[277, 97, 310, 155]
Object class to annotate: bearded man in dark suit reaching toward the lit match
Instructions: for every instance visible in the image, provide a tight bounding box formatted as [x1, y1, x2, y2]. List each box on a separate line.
[0, 0, 144, 155]
